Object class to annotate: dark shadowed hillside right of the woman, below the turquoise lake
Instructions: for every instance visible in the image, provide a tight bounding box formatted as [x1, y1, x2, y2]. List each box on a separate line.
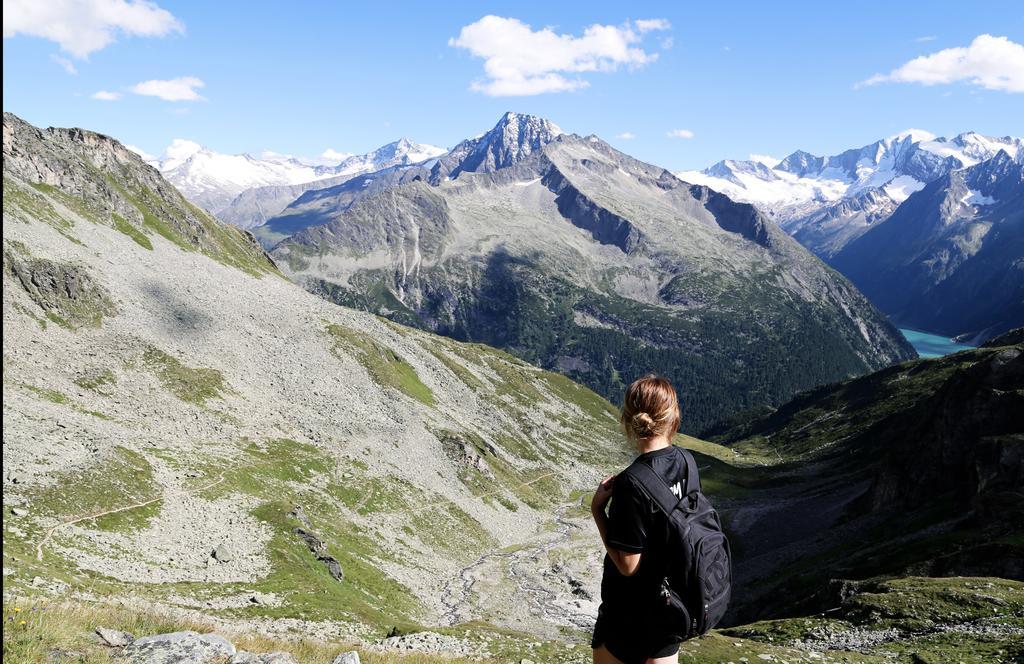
[708, 343, 1024, 622]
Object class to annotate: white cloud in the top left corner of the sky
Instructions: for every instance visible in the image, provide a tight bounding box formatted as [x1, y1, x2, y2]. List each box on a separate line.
[3, 0, 184, 58]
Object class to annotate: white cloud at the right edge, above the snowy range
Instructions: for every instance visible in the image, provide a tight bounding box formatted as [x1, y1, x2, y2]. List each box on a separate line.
[858, 35, 1024, 92]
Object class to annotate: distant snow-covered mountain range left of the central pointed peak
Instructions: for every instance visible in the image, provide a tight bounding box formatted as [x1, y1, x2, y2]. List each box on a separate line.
[150, 138, 444, 229]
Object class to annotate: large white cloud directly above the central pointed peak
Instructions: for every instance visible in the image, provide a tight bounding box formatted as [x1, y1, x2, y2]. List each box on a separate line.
[449, 15, 669, 96]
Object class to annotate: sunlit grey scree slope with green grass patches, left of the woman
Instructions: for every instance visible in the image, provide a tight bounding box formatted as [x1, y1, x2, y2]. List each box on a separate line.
[3, 115, 627, 639]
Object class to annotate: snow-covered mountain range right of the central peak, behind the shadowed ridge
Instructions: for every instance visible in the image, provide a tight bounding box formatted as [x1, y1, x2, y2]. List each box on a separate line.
[677, 130, 1024, 259]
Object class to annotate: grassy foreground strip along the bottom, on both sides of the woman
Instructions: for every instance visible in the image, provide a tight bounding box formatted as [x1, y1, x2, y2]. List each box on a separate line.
[9, 577, 1024, 664]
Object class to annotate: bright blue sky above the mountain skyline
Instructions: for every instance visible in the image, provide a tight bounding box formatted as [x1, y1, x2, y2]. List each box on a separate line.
[3, 0, 1024, 170]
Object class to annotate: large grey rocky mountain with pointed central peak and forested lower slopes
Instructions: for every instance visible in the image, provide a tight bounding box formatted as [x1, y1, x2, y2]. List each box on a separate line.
[266, 114, 913, 431]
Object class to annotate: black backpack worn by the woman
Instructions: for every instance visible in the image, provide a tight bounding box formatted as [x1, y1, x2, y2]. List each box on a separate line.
[625, 448, 732, 640]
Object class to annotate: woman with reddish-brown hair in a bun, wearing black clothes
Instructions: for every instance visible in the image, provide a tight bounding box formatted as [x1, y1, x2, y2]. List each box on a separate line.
[591, 375, 686, 664]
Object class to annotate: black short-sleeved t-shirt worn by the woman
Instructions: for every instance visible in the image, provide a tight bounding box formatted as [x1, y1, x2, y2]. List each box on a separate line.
[601, 447, 687, 624]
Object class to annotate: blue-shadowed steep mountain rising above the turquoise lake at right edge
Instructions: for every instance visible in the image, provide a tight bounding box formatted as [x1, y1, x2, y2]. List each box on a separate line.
[831, 151, 1024, 343]
